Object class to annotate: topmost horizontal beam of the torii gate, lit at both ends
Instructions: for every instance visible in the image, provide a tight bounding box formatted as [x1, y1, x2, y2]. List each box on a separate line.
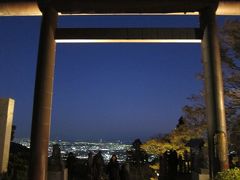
[0, 0, 240, 16]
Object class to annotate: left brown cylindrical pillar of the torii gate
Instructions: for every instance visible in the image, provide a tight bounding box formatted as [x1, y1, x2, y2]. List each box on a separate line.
[29, 7, 58, 180]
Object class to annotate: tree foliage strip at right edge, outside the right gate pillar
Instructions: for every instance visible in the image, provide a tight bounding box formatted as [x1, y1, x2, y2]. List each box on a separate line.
[221, 20, 240, 154]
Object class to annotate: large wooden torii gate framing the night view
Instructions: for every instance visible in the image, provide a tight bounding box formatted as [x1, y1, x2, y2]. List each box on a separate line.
[0, 0, 240, 180]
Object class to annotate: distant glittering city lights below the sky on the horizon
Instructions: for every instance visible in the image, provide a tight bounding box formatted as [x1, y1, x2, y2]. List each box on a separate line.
[14, 138, 131, 162]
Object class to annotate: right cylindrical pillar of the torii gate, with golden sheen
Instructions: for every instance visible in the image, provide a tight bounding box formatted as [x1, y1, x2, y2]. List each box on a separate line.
[200, 7, 229, 178]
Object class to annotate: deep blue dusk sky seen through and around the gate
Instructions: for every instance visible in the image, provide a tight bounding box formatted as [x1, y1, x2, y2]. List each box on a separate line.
[0, 16, 236, 140]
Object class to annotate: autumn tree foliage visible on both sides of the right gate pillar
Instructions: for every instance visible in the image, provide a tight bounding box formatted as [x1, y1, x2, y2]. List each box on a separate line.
[142, 20, 240, 160]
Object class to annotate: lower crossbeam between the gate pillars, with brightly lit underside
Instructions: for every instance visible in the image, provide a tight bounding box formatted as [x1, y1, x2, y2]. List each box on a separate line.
[55, 28, 202, 43]
